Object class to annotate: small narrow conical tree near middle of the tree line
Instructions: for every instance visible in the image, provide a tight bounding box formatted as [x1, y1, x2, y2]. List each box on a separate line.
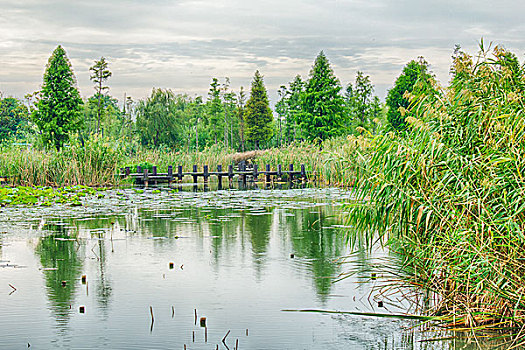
[245, 71, 273, 149]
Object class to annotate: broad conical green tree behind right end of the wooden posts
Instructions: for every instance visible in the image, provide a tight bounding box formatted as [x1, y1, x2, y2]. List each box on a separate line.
[299, 51, 345, 140]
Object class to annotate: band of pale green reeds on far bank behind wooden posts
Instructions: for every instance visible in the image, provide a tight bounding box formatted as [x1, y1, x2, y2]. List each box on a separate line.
[0, 136, 365, 187]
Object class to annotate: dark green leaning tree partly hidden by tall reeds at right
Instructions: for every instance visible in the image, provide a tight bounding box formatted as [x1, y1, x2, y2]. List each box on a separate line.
[386, 57, 432, 130]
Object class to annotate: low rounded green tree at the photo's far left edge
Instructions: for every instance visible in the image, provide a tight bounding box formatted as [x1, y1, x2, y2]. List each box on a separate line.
[0, 95, 30, 140]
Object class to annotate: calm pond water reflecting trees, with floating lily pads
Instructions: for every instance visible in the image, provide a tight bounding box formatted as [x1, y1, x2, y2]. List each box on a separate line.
[0, 189, 482, 350]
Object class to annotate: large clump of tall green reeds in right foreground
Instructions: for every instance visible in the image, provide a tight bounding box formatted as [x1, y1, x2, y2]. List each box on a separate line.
[348, 48, 525, 344]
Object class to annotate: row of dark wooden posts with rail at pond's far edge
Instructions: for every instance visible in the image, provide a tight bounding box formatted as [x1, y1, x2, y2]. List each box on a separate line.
[120, 163, 308, 187]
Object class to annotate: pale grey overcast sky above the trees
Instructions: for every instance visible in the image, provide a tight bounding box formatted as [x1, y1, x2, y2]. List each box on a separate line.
[0, 0, 525, 104]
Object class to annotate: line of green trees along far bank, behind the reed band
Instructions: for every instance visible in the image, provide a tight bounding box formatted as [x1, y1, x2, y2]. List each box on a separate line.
[0, 46, 433, 151]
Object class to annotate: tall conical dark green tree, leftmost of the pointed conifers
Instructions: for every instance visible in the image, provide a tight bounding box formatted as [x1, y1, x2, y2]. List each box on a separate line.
[33, 45, 82, 149]
